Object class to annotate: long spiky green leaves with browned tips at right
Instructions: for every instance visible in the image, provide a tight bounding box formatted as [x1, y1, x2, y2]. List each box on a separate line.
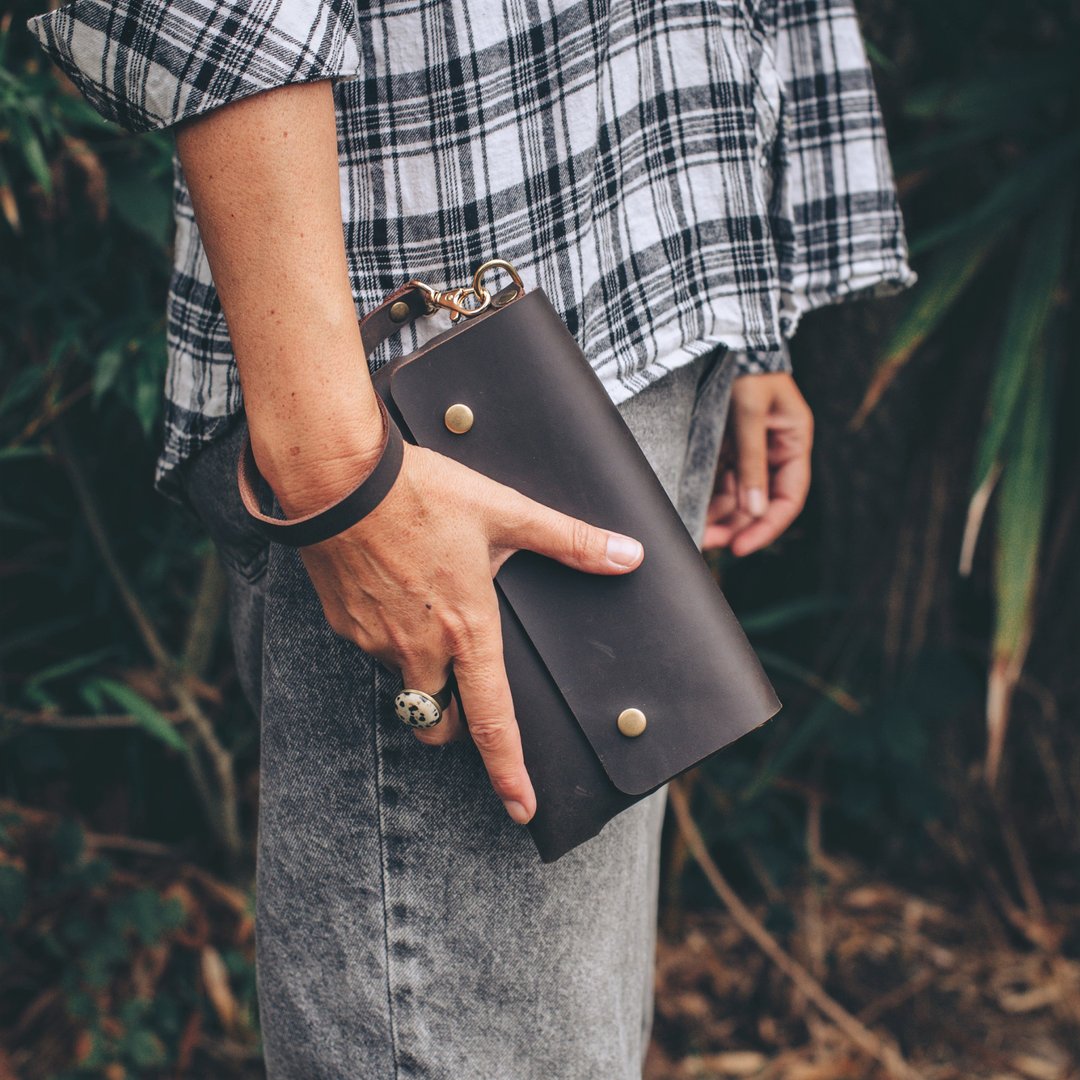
[854, 2, 1080, 778]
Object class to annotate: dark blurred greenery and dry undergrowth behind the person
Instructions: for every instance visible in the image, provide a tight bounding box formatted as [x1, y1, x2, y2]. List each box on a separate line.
[0, 0, 1080, 1080]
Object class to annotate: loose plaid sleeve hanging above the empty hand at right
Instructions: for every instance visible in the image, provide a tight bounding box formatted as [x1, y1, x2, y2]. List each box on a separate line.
[770, 0, 916, 336]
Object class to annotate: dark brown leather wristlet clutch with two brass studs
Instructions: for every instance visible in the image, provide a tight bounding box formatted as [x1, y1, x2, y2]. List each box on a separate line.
[240, 259, 780, 862]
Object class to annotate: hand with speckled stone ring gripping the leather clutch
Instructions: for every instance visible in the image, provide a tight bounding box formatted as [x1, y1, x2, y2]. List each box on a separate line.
[283, 443, 643, 824]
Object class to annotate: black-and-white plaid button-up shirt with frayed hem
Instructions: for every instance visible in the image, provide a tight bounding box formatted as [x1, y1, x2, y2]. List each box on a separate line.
[27, 0, 914, 495]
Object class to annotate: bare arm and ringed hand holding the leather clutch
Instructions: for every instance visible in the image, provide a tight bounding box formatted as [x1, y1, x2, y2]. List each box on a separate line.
[169, 80, 643, 823]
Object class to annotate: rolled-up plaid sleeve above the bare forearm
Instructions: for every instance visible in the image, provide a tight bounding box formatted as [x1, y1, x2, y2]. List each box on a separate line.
[26, 0, 360, 133]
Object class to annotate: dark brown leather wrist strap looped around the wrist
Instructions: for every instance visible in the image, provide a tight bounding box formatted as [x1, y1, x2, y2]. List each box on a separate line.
[237, 394, 405, 548]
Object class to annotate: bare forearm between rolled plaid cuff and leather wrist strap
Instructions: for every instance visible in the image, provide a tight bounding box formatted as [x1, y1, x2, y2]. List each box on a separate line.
[176, 80, 381, 513]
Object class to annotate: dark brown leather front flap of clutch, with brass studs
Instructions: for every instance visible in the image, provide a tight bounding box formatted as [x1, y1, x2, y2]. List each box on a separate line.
[376, 292, 780, 795]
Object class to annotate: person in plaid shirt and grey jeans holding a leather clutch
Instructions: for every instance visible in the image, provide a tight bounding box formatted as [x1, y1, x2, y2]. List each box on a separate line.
[28, 0, 912, 1080]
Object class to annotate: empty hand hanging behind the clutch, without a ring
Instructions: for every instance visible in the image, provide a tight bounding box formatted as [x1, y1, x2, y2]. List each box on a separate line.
[702, 372, 813, 555]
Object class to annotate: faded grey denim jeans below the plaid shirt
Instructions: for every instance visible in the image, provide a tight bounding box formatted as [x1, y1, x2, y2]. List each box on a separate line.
[177, 351, 733, 1080]
